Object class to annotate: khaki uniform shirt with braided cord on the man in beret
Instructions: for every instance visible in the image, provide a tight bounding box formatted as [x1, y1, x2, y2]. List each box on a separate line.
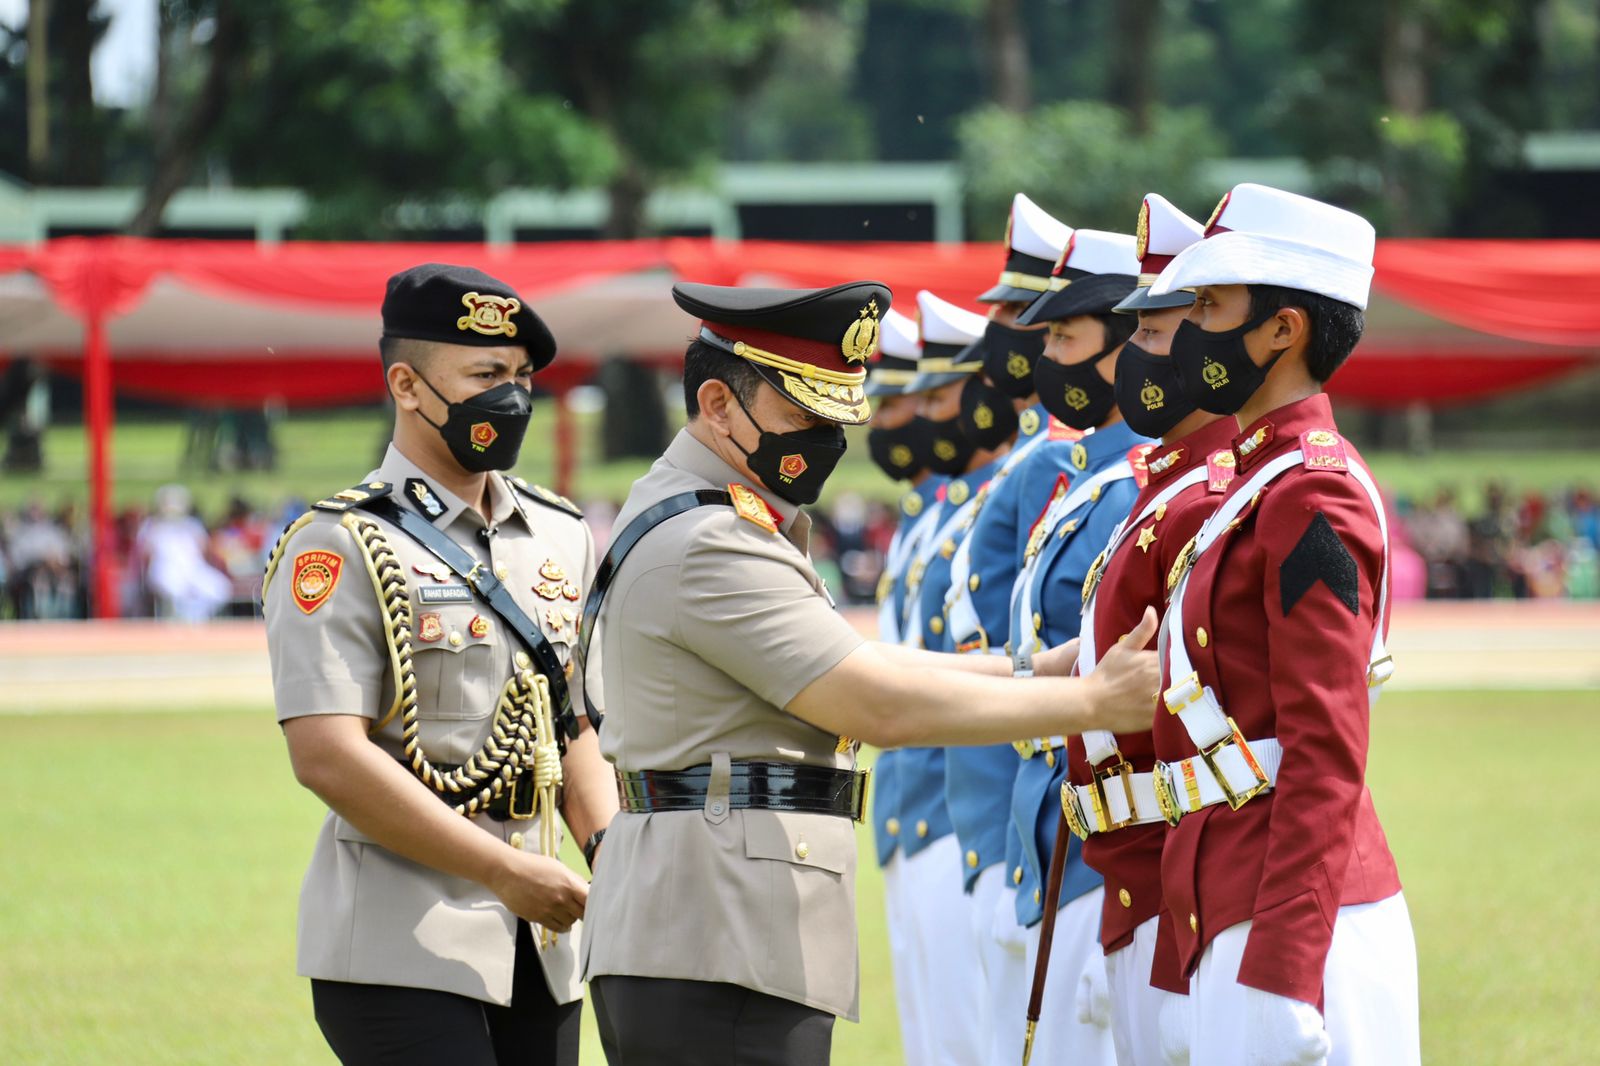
[266, 447, 595, 1005]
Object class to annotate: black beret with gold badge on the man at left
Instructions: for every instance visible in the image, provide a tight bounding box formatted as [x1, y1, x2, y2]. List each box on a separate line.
[384, 262, 555, 370]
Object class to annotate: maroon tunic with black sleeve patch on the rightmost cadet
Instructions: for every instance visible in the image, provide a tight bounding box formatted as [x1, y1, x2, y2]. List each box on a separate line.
[1154, 394, 1400, 1004]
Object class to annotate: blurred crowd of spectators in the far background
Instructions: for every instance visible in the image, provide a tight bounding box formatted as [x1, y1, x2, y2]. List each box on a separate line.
[0, 483, 1600, 621]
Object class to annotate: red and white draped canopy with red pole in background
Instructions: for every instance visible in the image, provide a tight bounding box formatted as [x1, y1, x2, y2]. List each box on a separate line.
[0, 237, 1600, 610]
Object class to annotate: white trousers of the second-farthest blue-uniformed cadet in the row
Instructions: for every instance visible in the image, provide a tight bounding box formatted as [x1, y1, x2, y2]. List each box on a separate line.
[904, 832, 979, 1066]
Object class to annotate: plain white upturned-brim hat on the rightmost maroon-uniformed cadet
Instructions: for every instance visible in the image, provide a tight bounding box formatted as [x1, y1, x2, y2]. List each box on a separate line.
[1150, 182, 1378, 311]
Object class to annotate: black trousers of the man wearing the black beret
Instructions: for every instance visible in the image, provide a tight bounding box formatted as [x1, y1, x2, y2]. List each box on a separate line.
[310, 922, 584, 1066]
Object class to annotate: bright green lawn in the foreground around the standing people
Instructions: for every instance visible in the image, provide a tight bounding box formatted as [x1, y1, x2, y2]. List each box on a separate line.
[0, 691, 1600, 1066]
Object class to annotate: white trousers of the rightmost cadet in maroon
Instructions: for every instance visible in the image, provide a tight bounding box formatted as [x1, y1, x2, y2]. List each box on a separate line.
[1189, 893, 1422, 1066]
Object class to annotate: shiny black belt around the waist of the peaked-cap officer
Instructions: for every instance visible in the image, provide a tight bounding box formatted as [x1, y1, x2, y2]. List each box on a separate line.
[616, 762, 867, 821]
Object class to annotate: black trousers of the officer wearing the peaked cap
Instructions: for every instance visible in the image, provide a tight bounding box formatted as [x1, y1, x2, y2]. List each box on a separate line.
[589, 976, 834, 1066]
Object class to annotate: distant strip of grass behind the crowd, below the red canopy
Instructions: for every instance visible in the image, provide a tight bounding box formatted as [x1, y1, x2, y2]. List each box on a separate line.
[9, 400, 1595, 517]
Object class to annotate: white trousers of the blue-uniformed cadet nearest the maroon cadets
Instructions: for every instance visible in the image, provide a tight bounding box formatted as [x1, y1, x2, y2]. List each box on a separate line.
[1016, 888, 1117, 1066]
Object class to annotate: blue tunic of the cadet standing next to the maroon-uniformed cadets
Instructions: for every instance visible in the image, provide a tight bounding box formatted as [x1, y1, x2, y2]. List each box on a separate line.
[1006, 423, 1152, 927]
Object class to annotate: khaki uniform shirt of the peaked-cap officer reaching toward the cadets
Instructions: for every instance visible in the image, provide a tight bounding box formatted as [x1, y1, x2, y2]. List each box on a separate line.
[584, 431, 861, 1020]
